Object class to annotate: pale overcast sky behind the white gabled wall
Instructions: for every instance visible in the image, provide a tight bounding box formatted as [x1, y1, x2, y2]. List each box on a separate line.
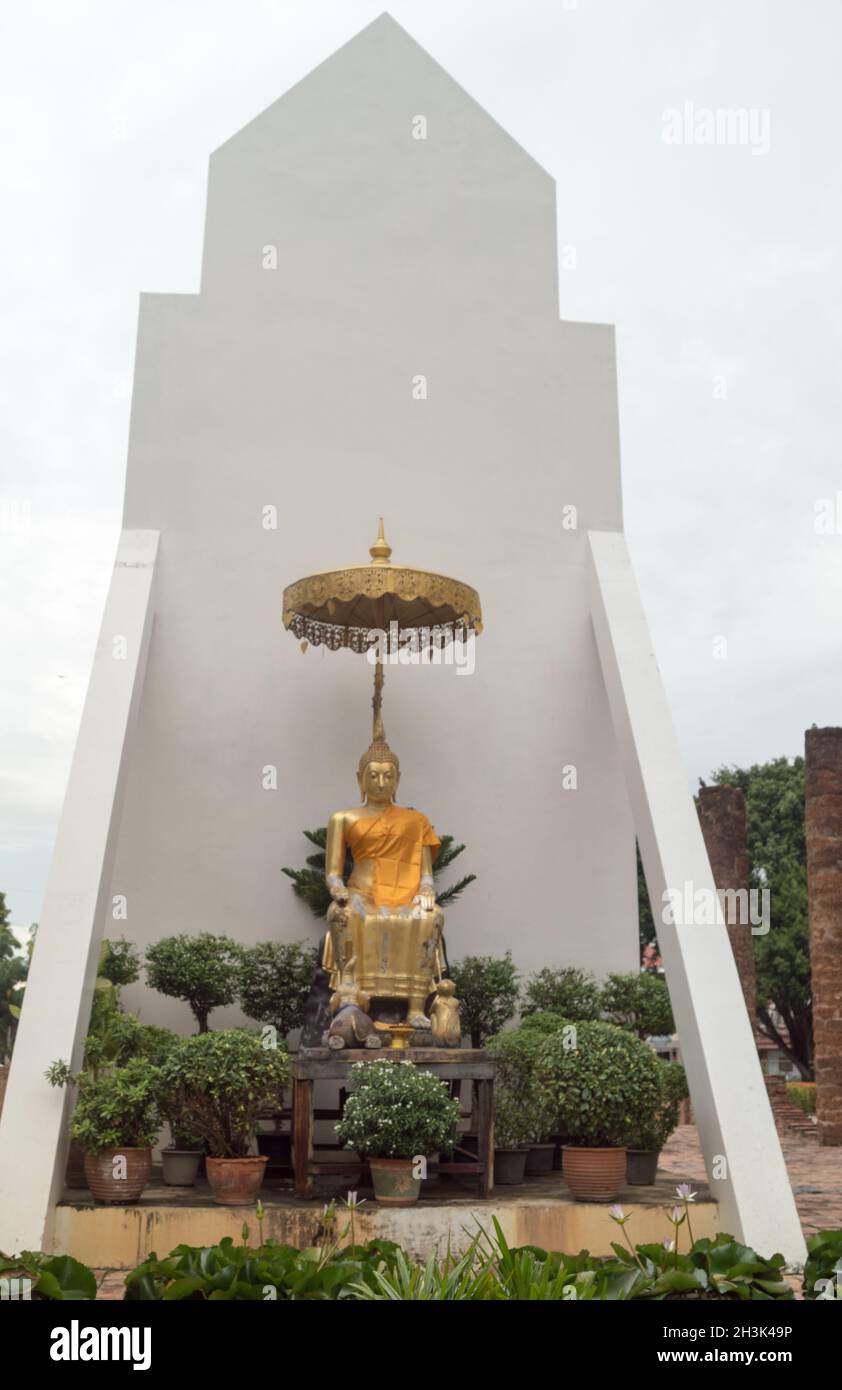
[0, 0, 842, 923]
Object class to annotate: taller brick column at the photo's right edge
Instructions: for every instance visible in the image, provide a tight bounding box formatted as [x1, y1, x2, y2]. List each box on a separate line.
[804, 728, 842, 1144]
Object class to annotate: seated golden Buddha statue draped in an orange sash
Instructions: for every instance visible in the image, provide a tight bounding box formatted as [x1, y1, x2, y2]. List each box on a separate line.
[322, 666, 445, 1031]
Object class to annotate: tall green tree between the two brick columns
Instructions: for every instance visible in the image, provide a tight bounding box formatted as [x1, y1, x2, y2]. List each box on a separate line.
[713, 758, 813, 1080]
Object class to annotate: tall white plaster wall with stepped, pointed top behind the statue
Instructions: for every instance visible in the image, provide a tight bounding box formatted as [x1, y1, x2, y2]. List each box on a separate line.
[113, 17, 638, 1026]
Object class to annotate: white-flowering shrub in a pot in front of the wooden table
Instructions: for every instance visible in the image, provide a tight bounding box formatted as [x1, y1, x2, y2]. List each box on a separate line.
[336, 1058, 460, 1207]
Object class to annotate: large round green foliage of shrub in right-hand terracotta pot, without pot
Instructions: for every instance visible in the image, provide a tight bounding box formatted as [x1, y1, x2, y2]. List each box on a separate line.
[536, 1022, 661, 1148]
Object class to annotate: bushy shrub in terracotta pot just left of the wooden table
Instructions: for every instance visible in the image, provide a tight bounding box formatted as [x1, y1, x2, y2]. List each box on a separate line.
[160, 1029, 289, 1207]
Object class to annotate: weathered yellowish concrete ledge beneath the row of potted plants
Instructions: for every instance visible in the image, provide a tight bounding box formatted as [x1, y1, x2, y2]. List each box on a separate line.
[53, 1173, 720, 1269]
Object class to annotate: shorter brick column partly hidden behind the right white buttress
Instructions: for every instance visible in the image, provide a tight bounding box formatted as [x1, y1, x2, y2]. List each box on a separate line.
[699, 784, 757, 1027]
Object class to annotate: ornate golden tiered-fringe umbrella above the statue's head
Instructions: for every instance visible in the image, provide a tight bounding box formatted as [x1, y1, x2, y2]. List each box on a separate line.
[283, 517, 482, 721]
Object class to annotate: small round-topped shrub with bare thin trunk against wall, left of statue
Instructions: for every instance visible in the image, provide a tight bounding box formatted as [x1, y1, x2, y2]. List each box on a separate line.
[146, 931, 242, 1033]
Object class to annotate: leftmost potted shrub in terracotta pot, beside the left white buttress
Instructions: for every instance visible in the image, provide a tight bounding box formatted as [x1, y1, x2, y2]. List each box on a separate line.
[47, 1058, 161, 1202]
